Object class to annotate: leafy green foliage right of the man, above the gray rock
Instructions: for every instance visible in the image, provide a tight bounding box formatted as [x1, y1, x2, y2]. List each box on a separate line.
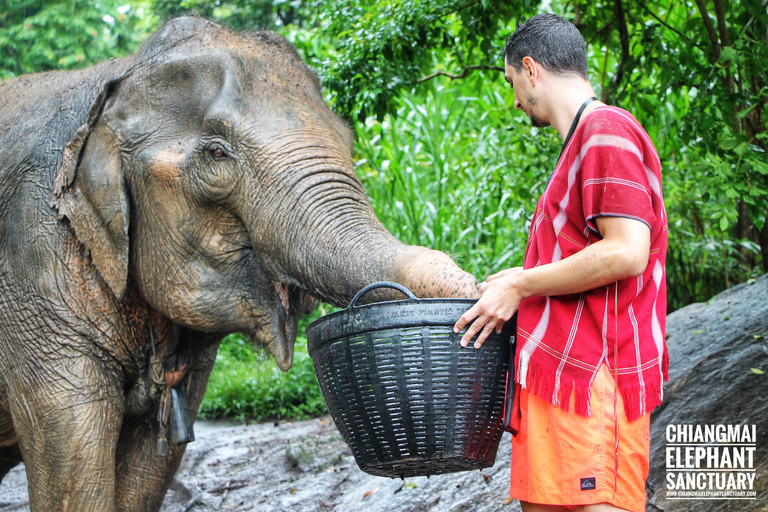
[568, 0, 768, 309]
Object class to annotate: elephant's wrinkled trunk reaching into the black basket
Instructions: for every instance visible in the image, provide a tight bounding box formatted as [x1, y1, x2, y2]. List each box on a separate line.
[243, 142, 477, 368]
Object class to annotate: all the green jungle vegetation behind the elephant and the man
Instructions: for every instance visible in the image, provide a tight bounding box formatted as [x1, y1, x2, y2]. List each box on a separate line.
[0, 0, 768, 421]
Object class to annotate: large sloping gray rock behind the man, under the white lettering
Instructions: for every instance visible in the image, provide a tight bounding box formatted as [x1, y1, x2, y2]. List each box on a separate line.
[647, 275, 768, 512]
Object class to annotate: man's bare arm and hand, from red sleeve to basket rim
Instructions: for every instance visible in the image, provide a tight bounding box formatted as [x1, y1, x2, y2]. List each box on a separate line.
[454, 217, 651, 348]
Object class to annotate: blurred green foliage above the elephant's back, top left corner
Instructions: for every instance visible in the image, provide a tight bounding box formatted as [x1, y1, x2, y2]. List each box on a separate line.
[0, 0, 154, 80]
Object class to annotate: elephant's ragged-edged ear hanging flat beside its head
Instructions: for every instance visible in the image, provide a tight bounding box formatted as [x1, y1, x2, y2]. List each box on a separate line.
[51, 79, 130, 299]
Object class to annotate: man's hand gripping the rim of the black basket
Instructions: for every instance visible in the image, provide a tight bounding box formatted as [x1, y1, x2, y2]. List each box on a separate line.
[453, 267, 524, 348]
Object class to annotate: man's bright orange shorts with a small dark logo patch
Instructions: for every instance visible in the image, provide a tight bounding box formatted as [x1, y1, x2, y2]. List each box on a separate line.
[509, 364, 650, 512]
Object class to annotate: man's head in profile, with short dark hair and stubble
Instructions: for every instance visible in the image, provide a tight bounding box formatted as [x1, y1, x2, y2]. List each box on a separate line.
[504, 14, 589, 127]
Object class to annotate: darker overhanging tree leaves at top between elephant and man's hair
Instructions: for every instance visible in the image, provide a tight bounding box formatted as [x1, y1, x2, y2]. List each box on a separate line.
[306, 0, 520, 121]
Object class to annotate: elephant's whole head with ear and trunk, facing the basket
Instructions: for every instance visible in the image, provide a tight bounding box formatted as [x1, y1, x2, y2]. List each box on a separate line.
[53, 17, 476, 369]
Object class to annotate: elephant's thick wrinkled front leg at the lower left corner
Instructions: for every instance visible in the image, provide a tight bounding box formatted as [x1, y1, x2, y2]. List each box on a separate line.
[8, 355, 124, 512]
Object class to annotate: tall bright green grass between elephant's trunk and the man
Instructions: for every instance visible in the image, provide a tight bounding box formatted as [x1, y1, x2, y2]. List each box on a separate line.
[356, 77, 561, 279]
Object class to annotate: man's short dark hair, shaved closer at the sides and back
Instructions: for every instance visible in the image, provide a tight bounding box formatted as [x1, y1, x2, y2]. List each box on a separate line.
[504, 14, 589, 80]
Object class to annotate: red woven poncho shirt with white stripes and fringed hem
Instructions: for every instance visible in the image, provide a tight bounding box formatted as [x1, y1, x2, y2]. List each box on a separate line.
[516, 106, 668, 421]
